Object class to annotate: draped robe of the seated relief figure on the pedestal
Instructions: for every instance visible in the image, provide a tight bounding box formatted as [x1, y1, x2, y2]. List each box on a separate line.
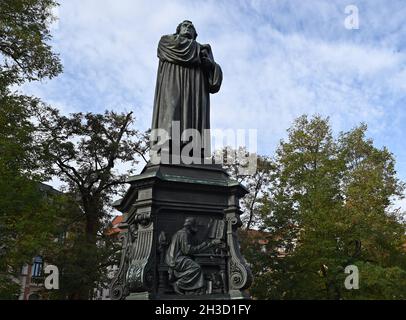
[165, 229, 206, 291]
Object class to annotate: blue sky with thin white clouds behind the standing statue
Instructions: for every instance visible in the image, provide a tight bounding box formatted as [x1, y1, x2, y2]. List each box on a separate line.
[23, 0, 406, 208]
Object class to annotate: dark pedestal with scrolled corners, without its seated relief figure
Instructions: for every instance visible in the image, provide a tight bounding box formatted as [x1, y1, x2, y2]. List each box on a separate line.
[111, 164, 252, 299]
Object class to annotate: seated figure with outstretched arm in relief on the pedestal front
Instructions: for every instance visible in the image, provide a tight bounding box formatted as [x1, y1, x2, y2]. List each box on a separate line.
[166, 218, 221, 294]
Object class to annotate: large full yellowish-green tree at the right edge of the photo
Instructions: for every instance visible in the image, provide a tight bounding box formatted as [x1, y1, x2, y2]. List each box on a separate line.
[252, 116, 406, 299]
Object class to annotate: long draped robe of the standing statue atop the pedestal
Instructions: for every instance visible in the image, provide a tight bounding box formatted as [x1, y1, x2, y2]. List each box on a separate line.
[152, 35, 223, 137]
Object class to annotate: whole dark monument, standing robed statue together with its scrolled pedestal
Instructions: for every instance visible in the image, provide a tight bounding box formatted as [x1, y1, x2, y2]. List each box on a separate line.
[110, 20, 252, 300]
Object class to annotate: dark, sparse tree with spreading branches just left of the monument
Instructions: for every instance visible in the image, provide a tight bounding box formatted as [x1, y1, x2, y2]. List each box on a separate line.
[38, 107, 149, 299]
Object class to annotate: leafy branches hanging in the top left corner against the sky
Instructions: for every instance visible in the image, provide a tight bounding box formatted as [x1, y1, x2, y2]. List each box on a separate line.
[0, 0, 62, 87]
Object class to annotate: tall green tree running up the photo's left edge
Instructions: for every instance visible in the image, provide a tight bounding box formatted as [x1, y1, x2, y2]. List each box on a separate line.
[0, 0, 62, 298]
